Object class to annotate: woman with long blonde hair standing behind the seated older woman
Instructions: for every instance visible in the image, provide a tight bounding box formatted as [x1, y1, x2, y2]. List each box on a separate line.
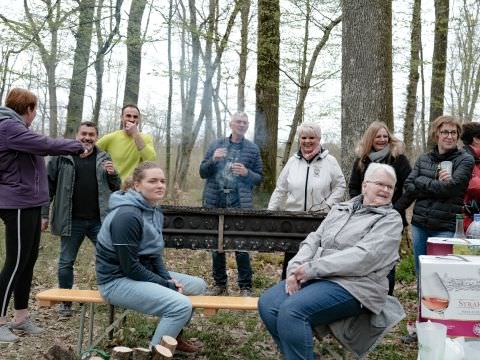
[348, 121, 412, 295]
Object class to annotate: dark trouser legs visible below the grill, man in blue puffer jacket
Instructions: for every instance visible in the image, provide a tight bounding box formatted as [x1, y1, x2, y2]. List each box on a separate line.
[212, 250, 252, 289]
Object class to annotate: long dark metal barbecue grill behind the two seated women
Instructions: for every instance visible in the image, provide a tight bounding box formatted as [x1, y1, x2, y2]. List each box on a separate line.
[162, 206, 326, 252]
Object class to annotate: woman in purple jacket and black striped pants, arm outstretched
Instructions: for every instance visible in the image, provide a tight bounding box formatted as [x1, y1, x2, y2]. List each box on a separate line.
[0, 88, 84, 342]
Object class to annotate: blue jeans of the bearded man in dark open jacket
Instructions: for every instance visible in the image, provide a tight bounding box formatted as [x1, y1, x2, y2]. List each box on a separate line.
[58, 219, 102, 289]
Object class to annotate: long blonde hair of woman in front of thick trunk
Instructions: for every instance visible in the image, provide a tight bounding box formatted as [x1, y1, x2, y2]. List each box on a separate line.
[355, 121, 405, 170]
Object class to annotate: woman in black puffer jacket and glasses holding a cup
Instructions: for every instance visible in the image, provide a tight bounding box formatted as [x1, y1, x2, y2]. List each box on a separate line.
[395, 115, 474, 276]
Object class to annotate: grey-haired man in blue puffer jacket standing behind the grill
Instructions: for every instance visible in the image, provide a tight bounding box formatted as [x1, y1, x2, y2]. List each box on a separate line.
[200, 112, 262, 296]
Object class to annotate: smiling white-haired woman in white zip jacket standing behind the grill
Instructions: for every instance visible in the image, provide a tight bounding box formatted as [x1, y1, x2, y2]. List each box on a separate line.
[268, 123, 346, 279]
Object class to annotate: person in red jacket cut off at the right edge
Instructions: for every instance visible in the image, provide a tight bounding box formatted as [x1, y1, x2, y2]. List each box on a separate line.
[461, 122, 480, 230]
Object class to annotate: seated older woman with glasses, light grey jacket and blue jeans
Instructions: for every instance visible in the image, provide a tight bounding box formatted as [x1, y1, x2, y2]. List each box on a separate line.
[259, 163, 404, 360]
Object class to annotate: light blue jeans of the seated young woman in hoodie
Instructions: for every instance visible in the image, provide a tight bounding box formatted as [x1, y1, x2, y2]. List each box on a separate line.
[98, 272, 207, 345]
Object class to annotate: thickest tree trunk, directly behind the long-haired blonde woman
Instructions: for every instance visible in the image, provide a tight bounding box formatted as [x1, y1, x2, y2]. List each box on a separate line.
[342, 0, 393, 180]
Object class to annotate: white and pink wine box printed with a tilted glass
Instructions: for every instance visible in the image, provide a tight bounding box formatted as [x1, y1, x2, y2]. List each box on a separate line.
[419, 255, 480, 338]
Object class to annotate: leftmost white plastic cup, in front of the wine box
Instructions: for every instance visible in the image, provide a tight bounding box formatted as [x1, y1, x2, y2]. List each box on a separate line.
[416, 321, 447, 360]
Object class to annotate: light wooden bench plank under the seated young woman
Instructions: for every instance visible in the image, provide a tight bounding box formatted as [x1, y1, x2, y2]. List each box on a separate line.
[36, 289, 258, 313]
